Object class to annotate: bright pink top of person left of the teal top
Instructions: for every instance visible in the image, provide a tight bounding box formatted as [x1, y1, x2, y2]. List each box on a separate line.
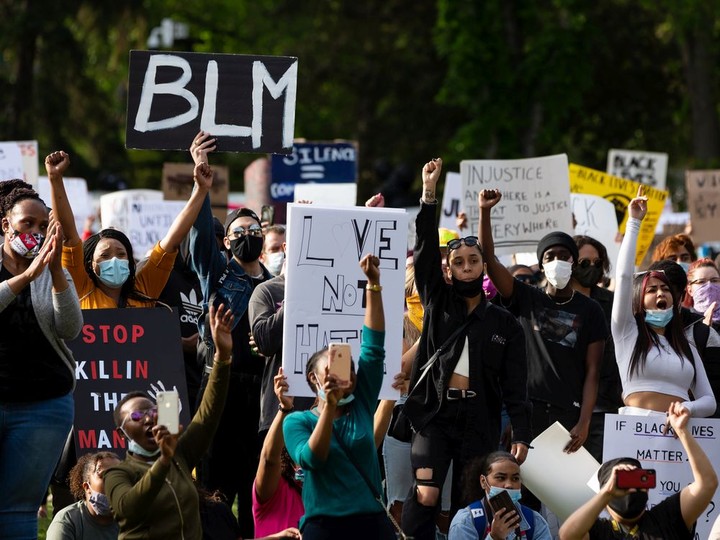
[253, 478, 305, 538]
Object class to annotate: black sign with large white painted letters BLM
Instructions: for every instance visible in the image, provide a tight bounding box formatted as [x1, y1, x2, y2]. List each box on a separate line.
[125, 51, 298, 154]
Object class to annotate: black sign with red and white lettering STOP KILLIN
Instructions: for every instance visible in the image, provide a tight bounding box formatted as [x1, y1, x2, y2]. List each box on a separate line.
[68, 308, 190, 455]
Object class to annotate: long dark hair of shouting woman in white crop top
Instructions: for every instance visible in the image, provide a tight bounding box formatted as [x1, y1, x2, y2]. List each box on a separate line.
[628, 271, 695, 380]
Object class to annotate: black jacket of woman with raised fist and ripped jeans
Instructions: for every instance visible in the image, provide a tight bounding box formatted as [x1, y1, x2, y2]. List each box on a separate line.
[404, 203, 532, 453]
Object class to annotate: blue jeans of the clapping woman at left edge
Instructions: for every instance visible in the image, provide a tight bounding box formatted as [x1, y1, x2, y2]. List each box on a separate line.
[0, 394, 75, 540]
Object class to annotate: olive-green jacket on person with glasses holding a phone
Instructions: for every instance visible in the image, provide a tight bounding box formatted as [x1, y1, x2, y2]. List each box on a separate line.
[105, 358, 230, 540]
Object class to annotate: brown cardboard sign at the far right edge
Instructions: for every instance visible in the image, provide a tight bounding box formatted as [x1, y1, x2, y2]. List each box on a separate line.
[685, 170, 720, 244]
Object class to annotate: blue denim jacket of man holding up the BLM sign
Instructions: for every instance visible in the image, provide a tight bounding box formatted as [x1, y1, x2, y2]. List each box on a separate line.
[190, 196, 258, 343]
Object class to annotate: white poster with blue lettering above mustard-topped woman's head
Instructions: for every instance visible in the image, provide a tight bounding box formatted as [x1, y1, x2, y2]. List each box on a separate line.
[125, 201, 185, 259]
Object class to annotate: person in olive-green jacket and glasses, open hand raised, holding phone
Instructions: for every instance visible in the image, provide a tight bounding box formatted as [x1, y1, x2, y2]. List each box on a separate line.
[105, 304, 233, 540]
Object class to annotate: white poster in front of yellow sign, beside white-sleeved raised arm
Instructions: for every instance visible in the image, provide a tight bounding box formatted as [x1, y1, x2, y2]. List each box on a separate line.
[570, 193, 620, 276]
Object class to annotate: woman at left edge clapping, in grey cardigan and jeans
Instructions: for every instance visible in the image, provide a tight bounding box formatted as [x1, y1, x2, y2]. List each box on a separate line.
[0, 180, 82, 538]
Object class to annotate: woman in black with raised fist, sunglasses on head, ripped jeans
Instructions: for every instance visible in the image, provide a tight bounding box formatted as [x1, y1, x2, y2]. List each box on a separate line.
[402, 159, 532, 540]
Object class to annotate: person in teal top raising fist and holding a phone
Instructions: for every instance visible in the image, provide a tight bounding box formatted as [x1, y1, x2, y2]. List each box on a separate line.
[283, 255, 395, 540]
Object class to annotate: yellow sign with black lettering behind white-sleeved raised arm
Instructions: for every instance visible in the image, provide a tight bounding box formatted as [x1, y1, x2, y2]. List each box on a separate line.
[569, 163, 668, 265]
